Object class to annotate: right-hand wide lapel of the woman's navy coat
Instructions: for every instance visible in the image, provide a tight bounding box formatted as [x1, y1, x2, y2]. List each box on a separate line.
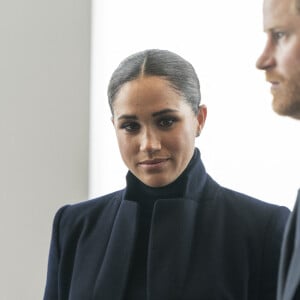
[147, 199, 198, 300]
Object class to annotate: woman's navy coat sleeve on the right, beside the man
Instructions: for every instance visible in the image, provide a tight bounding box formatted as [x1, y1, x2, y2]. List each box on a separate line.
[258, 207, 290, 300]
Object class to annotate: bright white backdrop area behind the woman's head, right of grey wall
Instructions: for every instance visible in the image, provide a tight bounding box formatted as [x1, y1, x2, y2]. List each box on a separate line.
[90, 0, 300, 208]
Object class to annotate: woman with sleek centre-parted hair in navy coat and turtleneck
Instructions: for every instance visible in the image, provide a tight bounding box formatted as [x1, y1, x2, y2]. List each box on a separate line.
[44, 50, 289, 300]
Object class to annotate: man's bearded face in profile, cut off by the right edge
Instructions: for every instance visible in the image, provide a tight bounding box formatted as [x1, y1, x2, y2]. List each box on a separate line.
[256, 0, 300, 119]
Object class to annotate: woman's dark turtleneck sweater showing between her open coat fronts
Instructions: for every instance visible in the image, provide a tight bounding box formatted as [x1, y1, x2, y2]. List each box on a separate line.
[124, 150, 199, 300]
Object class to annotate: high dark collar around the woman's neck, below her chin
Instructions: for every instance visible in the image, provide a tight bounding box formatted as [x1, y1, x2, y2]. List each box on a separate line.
[125, 148, 207, 203]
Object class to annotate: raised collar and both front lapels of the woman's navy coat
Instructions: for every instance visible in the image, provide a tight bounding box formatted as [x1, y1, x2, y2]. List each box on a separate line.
[93, 149, 207, 300]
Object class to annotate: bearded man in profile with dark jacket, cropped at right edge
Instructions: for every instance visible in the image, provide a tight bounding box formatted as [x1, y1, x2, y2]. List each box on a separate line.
[256, 0, 300, 300]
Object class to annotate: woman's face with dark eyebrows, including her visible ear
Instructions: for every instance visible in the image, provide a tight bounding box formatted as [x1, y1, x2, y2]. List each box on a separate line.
[112, 76, 206, 187]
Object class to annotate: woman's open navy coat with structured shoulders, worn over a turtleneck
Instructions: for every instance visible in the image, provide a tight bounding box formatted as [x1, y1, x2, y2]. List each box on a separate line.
[44, 154, 289, 300]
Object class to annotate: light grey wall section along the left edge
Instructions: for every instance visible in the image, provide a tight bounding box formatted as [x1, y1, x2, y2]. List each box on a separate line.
[0, 0, 90, 300]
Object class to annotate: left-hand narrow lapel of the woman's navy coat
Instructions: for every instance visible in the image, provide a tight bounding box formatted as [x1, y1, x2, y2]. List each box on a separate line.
[93, 200, 137, 300]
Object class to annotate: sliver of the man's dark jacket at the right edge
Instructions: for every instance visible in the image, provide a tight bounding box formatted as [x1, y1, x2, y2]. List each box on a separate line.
[277, 190, 300, 300]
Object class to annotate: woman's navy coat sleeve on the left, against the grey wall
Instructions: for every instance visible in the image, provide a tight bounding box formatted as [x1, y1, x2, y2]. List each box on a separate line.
[43, 206, 67, 300]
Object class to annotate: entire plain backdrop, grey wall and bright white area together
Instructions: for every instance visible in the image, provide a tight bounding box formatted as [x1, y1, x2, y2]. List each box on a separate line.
[0, 0, 300, 300]
